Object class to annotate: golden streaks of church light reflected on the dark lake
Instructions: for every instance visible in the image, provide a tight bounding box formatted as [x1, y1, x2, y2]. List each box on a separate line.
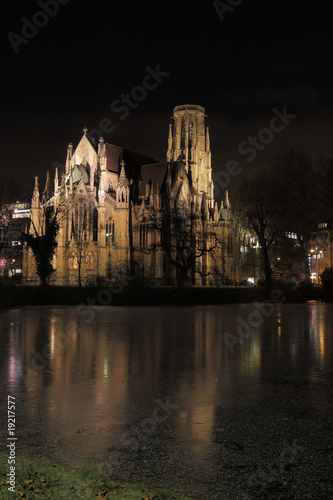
[0, 304, 333, 498]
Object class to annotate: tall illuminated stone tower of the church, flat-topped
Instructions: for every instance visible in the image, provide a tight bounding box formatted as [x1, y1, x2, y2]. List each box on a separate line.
[167, 104, 214, 208]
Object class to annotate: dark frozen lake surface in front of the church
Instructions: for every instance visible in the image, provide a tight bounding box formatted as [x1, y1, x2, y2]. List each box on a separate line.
[0, 303, 333, 500]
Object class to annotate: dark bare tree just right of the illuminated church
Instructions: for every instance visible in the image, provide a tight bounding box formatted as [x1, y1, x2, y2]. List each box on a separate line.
[234, 150, 319, 289]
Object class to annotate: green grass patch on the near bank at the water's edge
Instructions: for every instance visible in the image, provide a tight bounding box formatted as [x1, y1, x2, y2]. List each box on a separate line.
[0, 453, 193, 500]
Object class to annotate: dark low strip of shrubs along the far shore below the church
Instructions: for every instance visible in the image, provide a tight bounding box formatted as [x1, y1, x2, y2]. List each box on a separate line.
[0, 282, 333, 309]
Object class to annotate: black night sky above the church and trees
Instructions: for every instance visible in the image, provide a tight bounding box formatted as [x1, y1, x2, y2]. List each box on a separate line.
[0, 0, 333, 198]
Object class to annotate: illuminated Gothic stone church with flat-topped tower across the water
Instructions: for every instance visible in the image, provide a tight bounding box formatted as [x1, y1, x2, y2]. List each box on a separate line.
[23, 105, 234, 286]
